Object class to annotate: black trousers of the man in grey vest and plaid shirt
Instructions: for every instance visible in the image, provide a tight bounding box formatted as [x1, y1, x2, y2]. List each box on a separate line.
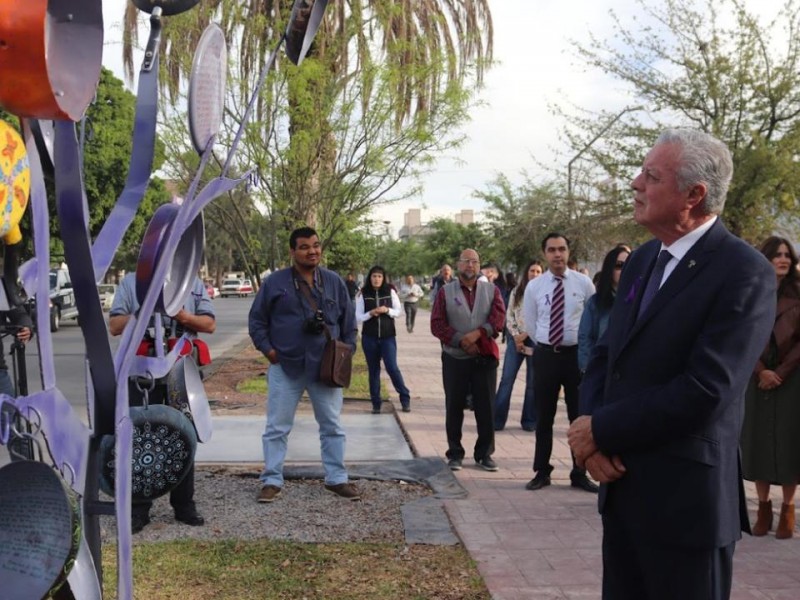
[442, 352, 497, 460]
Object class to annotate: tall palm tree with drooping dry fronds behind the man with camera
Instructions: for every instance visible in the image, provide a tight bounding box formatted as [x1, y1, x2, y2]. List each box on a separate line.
[123, 0, 493, 236]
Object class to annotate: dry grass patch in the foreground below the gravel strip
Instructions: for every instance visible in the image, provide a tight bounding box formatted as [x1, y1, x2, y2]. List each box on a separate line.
[103, 540, 491, 600]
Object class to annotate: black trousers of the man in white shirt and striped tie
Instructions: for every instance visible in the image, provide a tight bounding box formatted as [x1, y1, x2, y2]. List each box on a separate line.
[533, 344, 586, 478]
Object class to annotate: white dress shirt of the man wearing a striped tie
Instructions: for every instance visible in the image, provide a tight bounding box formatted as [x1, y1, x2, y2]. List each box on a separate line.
[522, 269, 594, 346]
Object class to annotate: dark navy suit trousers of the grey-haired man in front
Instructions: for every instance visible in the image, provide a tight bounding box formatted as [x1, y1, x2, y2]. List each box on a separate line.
[603, 502, 736, 600]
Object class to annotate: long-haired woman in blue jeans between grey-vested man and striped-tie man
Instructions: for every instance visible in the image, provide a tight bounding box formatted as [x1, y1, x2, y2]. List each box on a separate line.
[494, 260, 543, 431]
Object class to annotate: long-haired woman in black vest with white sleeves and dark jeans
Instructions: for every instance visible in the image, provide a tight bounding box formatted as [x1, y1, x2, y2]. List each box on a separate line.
[356, 265, 411, 415]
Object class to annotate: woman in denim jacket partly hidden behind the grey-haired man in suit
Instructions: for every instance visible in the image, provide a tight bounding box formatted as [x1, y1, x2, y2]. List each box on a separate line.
[578, 244, 631, 373]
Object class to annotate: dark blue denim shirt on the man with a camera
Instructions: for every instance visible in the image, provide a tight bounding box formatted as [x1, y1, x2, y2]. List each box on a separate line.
[248, 267, 357, 381]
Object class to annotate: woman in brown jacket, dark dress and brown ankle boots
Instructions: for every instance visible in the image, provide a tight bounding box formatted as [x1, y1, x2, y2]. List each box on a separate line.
[741, 236, 800, 539]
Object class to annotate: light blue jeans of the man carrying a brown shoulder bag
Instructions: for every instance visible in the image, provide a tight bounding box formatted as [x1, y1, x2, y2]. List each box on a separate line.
[260, 364, 347, 487]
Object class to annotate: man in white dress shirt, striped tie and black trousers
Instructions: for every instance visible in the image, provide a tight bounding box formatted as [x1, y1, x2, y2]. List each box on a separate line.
[522, 233, 598, 493]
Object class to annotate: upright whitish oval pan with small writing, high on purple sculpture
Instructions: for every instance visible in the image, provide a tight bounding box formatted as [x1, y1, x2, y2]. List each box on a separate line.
[189, 23, 228, 154]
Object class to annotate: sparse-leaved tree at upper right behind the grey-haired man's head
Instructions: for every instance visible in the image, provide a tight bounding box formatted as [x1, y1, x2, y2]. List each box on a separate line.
[556, 0, 800, 241]
